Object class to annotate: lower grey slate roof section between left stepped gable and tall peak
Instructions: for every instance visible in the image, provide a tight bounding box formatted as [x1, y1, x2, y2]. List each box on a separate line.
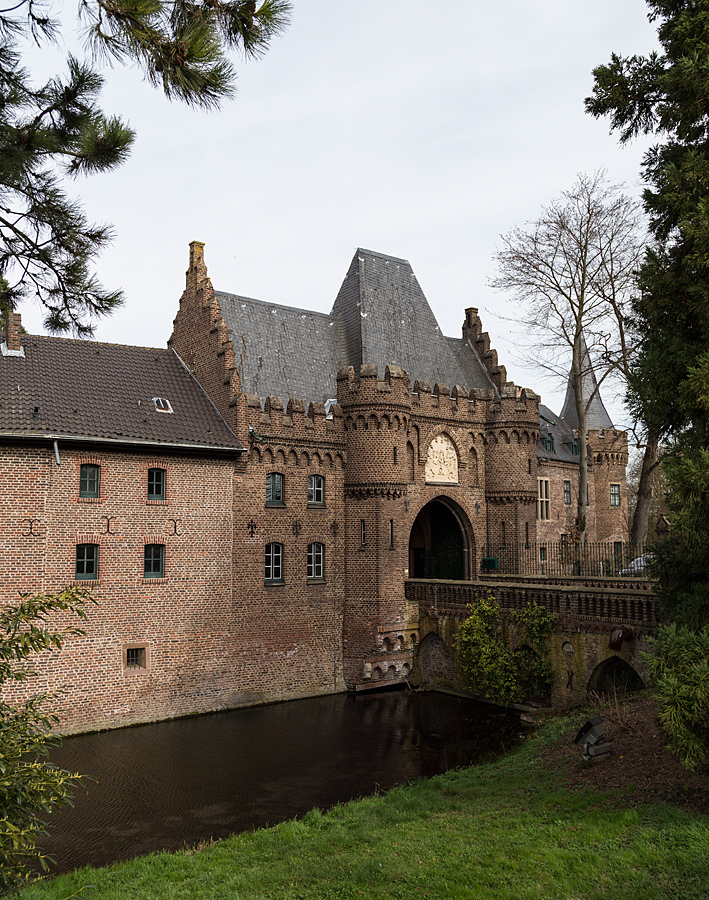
[215, 291, 343, 406]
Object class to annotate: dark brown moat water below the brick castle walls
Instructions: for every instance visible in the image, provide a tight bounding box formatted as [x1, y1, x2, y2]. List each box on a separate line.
[43, 691, 520, 872]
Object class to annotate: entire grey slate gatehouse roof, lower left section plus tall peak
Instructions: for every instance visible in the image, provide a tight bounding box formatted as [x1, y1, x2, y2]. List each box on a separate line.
[216, 249, 494, 404]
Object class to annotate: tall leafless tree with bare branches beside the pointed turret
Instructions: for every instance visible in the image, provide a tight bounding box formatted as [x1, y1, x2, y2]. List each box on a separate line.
[492, 171, 643, 545]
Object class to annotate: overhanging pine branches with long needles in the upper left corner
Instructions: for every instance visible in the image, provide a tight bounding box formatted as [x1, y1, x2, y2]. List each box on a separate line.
[0, 0, 290, 335]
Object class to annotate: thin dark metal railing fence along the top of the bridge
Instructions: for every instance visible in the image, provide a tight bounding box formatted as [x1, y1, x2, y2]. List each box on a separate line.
[481, 541, 647, 579]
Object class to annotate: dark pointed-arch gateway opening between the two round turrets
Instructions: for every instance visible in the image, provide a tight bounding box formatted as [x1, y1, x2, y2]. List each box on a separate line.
[409, 497, 474, 581]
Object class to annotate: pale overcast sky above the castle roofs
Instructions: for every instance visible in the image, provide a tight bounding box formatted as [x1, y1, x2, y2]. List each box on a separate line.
[21, 0, 656, 422]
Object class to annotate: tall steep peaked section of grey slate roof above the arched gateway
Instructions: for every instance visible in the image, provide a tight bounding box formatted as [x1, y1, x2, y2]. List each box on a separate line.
[331, 248, 491, 390]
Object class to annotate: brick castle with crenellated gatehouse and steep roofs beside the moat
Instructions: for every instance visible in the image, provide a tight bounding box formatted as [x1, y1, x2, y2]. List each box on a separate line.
[0, 242, 627, 731]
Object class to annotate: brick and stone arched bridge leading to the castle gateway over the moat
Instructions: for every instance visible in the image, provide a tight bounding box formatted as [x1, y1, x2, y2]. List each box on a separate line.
[406, 576, 657, 707]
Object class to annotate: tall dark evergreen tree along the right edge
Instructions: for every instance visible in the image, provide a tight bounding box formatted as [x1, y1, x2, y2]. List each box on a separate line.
[586, 0, 709, 628]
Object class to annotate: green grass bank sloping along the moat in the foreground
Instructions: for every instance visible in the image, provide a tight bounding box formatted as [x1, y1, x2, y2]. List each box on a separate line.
[22, 720, 709, 900]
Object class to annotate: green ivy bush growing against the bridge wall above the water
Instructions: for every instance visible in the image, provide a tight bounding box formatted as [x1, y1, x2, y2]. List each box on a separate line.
[455, 593, 557, 706]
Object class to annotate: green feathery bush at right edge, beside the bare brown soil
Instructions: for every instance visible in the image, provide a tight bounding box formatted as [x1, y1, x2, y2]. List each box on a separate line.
[644, 623, 709, 769]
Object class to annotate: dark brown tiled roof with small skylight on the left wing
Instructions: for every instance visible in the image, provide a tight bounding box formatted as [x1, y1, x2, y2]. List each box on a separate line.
[0, 334, 243, 452]
